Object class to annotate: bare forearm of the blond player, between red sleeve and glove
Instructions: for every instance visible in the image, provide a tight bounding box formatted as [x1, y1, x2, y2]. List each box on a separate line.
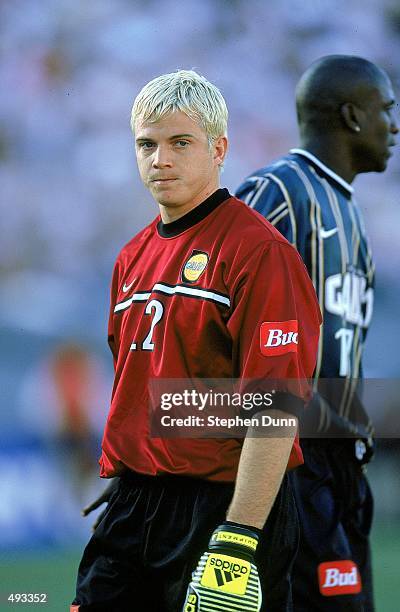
[227, 410, 296, 529]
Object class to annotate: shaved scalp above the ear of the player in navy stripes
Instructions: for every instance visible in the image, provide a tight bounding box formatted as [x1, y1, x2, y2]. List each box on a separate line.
[296, 55, 389, 130]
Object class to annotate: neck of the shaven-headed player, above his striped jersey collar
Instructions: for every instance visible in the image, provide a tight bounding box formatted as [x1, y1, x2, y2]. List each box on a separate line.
[300, 138, 357, 184]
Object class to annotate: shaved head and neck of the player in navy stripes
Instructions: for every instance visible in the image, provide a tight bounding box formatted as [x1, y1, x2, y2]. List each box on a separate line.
[296, 55, 399, 182]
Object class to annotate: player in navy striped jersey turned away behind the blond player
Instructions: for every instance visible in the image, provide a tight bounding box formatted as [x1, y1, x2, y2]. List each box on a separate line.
[237, 56, 398, 612]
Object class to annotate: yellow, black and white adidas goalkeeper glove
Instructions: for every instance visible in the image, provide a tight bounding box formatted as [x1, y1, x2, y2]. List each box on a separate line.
[183, 522, 262, 612]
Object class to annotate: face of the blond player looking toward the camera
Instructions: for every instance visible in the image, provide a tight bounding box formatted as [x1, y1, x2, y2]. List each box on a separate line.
[135, 111, 226, 222]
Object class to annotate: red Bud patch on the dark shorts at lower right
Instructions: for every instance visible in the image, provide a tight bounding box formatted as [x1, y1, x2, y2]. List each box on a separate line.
[318, 560, 361, 597]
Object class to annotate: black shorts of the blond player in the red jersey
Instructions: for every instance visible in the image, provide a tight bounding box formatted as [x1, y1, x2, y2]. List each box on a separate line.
[74, 472, 299, 612]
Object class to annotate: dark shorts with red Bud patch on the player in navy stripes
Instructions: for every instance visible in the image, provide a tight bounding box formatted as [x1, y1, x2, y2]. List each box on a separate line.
[290, 440, 374, 612]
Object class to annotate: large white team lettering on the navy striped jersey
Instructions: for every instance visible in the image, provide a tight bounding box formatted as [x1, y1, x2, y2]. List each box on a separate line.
[325, 272, 374, 328]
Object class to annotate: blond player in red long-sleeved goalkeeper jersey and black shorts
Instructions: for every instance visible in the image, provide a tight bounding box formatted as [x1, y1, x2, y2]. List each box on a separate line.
[71, 71, 321, 612]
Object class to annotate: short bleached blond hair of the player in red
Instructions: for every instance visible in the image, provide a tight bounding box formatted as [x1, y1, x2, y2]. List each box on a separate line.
[131, 70, 228, 146]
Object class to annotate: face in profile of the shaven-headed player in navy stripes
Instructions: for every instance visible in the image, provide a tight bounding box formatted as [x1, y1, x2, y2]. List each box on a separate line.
[354, 76, 399, 172]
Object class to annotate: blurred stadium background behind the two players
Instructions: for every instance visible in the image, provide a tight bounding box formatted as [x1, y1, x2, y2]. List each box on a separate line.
[0, 0, 400, 612]
